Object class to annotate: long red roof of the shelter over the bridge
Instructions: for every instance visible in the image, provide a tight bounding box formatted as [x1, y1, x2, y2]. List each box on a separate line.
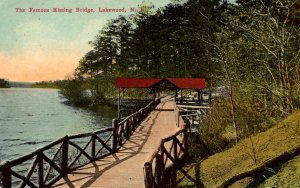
[116, 78, 206, 89]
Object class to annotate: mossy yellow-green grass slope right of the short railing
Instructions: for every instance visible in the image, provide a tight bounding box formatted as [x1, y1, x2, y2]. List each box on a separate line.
[176, 110, 300, 187]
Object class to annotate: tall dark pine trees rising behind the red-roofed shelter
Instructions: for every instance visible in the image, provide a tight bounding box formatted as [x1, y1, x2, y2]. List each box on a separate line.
[61, 0, 224, 104]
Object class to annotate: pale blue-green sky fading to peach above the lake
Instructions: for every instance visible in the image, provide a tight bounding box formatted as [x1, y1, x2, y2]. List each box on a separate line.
[0, 0, 170, 82]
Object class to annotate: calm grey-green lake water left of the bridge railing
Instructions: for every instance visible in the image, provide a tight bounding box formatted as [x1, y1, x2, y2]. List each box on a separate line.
[0, 88, 116, 161]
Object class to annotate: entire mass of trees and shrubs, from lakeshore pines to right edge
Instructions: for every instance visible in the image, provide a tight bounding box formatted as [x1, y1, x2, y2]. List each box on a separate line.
[62, 0, 300, 151]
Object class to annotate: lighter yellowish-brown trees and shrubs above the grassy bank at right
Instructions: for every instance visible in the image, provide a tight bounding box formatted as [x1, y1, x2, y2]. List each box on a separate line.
[193, 0, 300, 151]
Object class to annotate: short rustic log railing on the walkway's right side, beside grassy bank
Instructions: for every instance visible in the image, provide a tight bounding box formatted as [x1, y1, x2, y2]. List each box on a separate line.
[144, 107, 188, 188]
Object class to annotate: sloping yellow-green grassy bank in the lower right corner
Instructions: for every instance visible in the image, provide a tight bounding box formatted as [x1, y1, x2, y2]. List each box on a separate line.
[177, 110, 300, 187]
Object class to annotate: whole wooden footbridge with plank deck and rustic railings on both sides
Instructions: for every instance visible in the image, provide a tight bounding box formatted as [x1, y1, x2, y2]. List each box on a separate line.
[0, 100, 187, 188]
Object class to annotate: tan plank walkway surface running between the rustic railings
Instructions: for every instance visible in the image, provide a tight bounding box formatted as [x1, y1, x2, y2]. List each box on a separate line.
[53, 101, 178, 188]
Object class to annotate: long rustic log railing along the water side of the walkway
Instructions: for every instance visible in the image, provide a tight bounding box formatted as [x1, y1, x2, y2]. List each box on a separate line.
[0, 97, 160, 188]
